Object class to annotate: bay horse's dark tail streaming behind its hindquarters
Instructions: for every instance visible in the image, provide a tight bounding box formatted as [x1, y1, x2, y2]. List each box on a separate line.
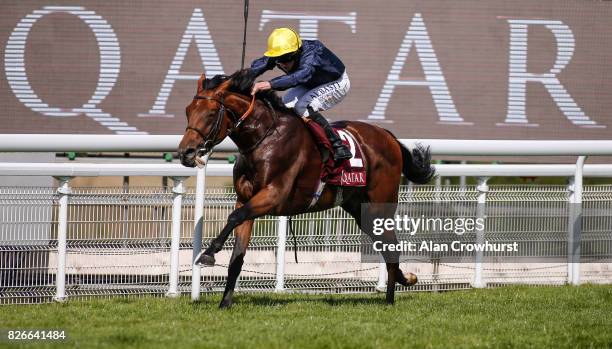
[386, 130, 436, 184]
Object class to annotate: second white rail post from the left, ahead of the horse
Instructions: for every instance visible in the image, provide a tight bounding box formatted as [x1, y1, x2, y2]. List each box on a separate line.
[166, 177, 187, 297]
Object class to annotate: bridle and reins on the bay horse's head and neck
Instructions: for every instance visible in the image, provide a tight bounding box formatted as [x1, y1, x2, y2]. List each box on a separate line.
[185, 94, 277, 156]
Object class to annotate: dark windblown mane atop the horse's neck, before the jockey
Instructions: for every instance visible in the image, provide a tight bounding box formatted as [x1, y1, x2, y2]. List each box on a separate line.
[202, 69, 290, 112]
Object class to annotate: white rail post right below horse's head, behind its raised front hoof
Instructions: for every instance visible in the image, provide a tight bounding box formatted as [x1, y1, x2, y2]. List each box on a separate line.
[191, 162, 208, 301]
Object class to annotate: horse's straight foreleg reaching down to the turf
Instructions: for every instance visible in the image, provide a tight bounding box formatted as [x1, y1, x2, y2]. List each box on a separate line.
[219, 219, 253, 308]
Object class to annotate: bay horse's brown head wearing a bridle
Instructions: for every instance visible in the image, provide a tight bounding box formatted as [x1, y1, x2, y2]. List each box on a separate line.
[178, 74, 237, 167]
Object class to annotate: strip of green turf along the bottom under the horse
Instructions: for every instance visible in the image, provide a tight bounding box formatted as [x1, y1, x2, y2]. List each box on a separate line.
[0, 285, 612, 349]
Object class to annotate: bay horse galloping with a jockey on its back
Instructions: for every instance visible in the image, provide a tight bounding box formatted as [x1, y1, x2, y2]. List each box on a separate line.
[178, 69, 435, 308]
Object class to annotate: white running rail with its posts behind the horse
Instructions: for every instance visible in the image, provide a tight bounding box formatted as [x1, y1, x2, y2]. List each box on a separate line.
[0, 135, 612, 301]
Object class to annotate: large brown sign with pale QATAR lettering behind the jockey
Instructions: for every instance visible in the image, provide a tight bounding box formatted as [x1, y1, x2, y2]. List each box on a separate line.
[0, 1, 612, 139]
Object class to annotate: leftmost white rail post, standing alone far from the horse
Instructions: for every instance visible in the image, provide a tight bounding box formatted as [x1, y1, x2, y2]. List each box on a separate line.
[53, 177, 72, 302]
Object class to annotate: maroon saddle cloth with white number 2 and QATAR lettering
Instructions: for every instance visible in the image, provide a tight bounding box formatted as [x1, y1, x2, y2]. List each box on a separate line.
[306, 121, 366, 187]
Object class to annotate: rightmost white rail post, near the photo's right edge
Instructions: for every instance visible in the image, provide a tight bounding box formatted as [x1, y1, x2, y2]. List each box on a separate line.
[567, 156, 586, 285]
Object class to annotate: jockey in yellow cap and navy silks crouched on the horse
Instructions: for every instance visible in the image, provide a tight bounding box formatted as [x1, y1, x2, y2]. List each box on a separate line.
[251, 28, 352, 161]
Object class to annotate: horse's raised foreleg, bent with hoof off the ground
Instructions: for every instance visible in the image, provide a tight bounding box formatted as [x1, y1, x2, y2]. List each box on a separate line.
[196, 186, 284, 266]
